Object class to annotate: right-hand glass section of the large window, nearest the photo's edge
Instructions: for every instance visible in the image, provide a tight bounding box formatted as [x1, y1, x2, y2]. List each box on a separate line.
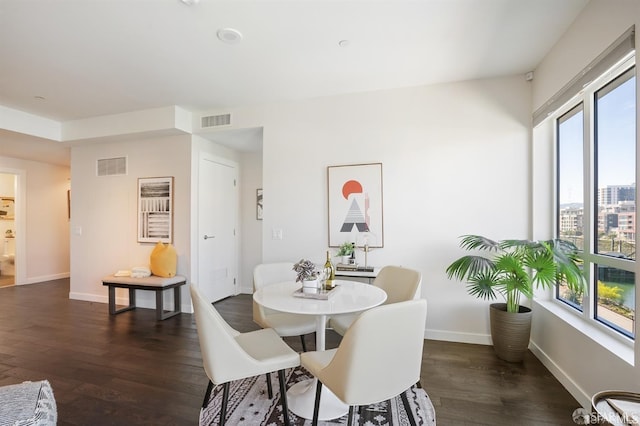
[593, 67, 636, 336]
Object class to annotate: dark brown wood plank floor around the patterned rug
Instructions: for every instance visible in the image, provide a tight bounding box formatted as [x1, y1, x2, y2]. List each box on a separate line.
[0, 280, 578, 426]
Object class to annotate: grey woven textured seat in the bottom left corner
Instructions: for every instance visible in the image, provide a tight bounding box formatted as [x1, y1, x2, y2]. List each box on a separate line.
[0, 380, 58, 426]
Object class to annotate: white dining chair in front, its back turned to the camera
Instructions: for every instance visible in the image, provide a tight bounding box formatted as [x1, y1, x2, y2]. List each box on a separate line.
[300, 299, 427, 426]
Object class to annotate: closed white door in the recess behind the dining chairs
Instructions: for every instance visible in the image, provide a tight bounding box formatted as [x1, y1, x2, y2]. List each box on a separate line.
[197, 154, 238, 302]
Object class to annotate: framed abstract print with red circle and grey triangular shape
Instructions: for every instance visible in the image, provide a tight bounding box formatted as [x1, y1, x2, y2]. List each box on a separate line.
[327, 163, 384, 247]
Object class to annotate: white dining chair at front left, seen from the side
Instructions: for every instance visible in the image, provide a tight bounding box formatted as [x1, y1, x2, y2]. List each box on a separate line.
[189, 284, 300, 425]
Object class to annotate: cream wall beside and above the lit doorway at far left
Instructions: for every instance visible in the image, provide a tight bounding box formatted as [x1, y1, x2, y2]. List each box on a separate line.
[0, 157, 70, 284]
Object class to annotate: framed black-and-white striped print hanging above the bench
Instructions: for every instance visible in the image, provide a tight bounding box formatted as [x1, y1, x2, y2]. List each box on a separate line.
[138, 176, 173, 243]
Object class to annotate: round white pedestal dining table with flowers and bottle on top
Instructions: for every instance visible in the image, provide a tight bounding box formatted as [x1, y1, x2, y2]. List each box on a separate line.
[253, 280, 387, 420]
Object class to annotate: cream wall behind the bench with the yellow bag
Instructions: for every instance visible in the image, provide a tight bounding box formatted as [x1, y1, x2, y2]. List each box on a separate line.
[70, 135, 191, 310]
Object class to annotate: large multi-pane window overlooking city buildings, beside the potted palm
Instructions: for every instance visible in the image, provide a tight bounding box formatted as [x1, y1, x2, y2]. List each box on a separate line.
[555, 57, 636, 338]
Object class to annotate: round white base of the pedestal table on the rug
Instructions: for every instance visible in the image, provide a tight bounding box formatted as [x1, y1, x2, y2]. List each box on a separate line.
[287, 379, 349, 420]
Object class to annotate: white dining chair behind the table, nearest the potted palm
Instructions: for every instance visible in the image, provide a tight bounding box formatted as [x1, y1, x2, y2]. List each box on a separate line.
[328, 265, 422, 336]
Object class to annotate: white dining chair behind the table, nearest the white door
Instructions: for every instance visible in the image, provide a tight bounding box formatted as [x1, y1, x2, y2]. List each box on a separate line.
[253, 262, 316, 352]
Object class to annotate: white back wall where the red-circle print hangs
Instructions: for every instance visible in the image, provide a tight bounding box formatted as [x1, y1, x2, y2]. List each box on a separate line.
[222, 76, 531, 343]
